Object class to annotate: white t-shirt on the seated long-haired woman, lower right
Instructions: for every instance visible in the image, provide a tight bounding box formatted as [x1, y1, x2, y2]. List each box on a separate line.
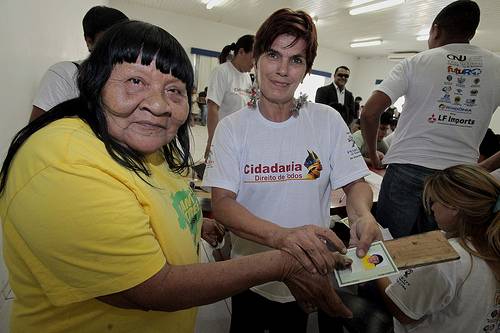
[386, 239, 500, 333]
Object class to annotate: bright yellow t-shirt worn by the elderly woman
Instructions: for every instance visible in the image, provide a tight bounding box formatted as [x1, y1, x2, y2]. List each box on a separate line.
[0, 119, 201, 333]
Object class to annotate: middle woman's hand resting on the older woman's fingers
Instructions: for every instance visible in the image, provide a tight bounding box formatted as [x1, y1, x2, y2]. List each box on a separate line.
[271, 225, 346, 274]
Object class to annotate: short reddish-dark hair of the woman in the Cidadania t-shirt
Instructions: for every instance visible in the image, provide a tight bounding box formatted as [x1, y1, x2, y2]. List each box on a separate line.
[253, 8, 318, 73]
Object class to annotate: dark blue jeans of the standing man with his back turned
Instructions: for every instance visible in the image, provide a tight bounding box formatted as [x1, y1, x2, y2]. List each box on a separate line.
[376, 164, 438, 238]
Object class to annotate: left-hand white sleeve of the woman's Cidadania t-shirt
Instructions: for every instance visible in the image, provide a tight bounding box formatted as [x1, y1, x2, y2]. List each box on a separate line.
[203, 118, 241, 194]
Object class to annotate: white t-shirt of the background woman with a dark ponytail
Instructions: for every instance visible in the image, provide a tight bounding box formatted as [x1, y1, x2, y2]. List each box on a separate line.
[207, 61, 252, 120]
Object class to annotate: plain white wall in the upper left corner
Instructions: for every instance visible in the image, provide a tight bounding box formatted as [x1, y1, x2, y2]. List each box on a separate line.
[0, 0, 108, 160]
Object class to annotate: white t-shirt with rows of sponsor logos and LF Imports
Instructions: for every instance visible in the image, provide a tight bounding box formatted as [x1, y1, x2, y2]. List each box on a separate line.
[377, 44, 500, 169]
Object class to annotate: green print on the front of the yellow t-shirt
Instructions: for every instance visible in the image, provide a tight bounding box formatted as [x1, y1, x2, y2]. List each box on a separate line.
[170, 191, 201, 245]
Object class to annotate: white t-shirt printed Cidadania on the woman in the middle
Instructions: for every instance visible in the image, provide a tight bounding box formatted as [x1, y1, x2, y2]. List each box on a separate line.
[203, 103, 369, 302]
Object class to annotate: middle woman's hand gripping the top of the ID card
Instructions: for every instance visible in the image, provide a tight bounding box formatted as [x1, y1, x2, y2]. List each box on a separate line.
[349, 214, 382, 258]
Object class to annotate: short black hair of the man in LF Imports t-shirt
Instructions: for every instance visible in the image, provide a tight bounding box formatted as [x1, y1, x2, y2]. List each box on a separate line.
[432, 0, 480, 40]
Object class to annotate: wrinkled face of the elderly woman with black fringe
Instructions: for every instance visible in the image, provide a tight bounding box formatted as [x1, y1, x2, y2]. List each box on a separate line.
[101, 59, 189, 154]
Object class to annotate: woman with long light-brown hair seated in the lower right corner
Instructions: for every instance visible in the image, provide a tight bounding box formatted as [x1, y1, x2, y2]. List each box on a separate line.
[377, 165, 500, 333]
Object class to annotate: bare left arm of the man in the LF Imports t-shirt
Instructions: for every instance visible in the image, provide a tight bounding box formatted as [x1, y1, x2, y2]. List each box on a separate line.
[361, 90, 391, 168]
